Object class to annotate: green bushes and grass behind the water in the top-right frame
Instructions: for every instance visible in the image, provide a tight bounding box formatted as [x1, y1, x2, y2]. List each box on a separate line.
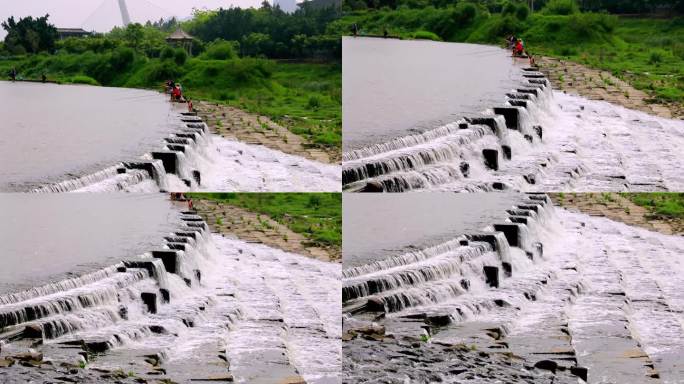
[330, 0, 684, 110]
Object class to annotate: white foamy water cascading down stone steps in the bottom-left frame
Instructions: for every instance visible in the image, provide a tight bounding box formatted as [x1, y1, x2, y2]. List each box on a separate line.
[0, 214, 341, 383]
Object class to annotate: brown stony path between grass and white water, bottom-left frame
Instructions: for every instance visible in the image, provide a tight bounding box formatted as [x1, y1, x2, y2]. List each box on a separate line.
[188, 200, 342, 262]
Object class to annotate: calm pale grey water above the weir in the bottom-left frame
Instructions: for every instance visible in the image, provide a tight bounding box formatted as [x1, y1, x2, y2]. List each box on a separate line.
[0, 193, 177, 294]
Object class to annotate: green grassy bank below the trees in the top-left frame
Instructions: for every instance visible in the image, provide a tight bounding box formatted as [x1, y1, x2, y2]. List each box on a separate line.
[0, 53, 342, 148]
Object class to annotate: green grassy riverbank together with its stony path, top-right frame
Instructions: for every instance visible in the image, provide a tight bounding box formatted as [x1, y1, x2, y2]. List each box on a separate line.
[330, 11, 684, 118]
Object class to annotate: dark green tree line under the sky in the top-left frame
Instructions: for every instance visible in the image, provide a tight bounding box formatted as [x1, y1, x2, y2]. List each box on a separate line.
[0, 0, 341, 60]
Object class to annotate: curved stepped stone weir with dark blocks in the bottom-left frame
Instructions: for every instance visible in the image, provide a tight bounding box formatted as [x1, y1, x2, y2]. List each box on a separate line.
[0, 211, 241, 382]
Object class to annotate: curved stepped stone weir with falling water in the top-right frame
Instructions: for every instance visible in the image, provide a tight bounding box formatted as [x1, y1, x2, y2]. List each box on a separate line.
[342, 68, 553, 192]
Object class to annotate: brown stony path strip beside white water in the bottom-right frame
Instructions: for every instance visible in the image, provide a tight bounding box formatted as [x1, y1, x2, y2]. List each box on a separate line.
[549, 193, 684, 235]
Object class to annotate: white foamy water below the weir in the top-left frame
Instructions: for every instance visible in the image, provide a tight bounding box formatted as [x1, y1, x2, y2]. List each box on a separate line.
[65, 134, 342, 192]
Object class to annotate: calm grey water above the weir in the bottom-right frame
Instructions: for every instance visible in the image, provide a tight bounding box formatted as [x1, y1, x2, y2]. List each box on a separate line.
[342, 192, 518, 268]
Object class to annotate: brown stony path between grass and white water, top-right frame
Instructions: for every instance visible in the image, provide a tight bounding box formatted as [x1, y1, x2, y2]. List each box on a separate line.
[537, 57, 684, 119]
